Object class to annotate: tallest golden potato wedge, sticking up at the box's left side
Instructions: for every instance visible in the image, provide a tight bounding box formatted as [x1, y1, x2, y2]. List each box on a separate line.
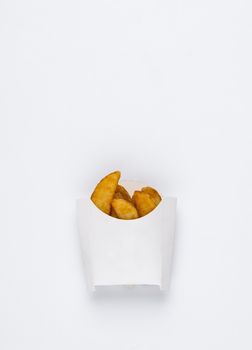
[91, 171, 121, 214]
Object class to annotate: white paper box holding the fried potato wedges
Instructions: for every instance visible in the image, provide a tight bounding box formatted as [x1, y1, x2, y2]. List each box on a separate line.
[77, 182, 176, 290]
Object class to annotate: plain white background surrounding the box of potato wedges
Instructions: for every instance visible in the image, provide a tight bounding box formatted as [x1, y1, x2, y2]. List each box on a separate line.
[0, 0, 252, 350]
